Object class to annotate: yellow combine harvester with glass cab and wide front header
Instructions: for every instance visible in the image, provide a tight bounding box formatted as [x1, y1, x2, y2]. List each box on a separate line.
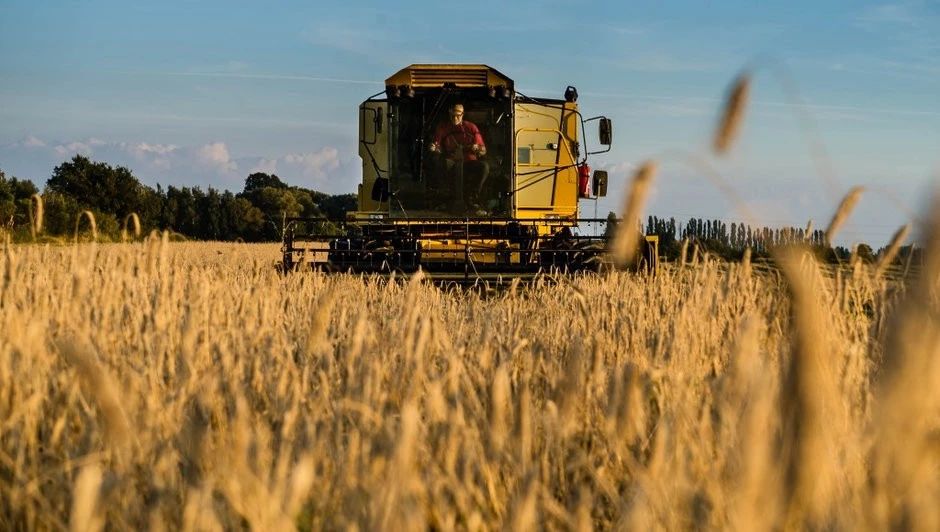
[283, 64, 658, 280]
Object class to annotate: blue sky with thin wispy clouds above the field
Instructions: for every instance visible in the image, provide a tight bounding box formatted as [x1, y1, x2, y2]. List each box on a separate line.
[0, 0, 940, 245]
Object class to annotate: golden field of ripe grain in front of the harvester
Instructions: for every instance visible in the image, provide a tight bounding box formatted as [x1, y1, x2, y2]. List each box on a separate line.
[0, 231, 940, 530]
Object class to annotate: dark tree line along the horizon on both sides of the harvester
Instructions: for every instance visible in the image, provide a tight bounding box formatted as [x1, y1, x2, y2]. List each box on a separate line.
[0, 155, 916, 262]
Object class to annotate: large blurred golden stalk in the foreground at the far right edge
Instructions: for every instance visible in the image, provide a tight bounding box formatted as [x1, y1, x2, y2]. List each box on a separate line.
[869, 197, 940, 530]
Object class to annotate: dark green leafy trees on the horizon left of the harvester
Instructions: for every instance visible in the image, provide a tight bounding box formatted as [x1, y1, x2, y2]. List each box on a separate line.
[0, 155, 356, 242]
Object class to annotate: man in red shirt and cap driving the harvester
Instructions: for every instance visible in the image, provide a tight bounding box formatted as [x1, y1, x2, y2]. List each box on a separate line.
[431, 103, 489, 210]
